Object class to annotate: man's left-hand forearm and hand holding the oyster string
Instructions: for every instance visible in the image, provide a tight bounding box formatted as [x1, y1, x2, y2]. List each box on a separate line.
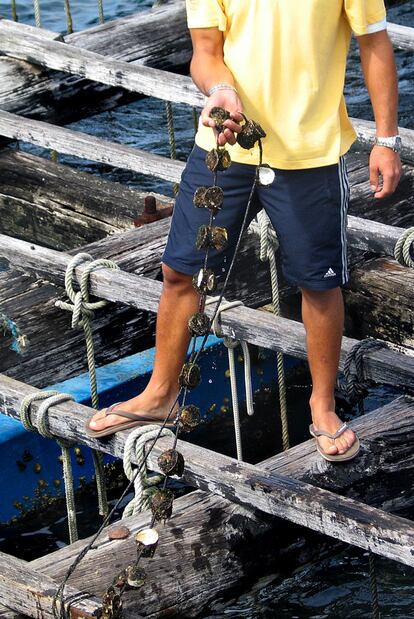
[190, 28, 243, 146]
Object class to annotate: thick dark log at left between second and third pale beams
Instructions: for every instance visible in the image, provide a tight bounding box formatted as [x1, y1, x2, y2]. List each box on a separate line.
[0, 148, 173, 251]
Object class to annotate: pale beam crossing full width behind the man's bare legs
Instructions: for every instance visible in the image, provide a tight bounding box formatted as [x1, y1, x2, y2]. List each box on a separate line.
[0, 235, 414, 388]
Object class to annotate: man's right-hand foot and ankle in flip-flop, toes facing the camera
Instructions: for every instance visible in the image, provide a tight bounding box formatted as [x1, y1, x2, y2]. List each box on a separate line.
[310, 398, 356, 456]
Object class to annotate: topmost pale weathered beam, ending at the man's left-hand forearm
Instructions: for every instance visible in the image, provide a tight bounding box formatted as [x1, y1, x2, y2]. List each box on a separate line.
[0, 19, 204, 106]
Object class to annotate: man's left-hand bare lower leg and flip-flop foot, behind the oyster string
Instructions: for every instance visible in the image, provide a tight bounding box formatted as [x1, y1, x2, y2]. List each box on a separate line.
[89, 264, 199, 430]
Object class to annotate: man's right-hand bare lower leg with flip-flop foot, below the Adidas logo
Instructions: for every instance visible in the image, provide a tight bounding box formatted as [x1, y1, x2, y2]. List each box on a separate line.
[302, 288, 355, 454]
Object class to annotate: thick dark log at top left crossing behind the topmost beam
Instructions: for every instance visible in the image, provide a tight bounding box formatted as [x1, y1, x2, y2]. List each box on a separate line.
[0, 2, 191, 124]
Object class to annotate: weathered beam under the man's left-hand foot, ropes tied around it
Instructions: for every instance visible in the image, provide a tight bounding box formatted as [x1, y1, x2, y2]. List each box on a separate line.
[0, 376, 414, 566]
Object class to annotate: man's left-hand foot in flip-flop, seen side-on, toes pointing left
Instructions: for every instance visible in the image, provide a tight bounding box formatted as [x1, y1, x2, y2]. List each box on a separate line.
[89, 391, 178, 432]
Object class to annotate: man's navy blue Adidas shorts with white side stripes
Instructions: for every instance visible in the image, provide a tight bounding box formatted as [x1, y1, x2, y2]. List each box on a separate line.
[162, 145, 349, 290]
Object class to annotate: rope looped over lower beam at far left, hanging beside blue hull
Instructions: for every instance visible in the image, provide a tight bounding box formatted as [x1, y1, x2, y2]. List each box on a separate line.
[20, 391, 78, 544]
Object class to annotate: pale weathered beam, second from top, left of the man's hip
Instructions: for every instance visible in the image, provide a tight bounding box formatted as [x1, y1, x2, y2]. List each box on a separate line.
[0, 111, 184, 183]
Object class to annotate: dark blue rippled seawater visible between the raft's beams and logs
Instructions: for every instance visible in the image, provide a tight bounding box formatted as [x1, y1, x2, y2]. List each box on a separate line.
[0, 0, 414, 619]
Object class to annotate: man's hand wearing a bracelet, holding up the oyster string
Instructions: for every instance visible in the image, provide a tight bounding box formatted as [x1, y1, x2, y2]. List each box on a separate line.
[201, 90, 243, 146]
